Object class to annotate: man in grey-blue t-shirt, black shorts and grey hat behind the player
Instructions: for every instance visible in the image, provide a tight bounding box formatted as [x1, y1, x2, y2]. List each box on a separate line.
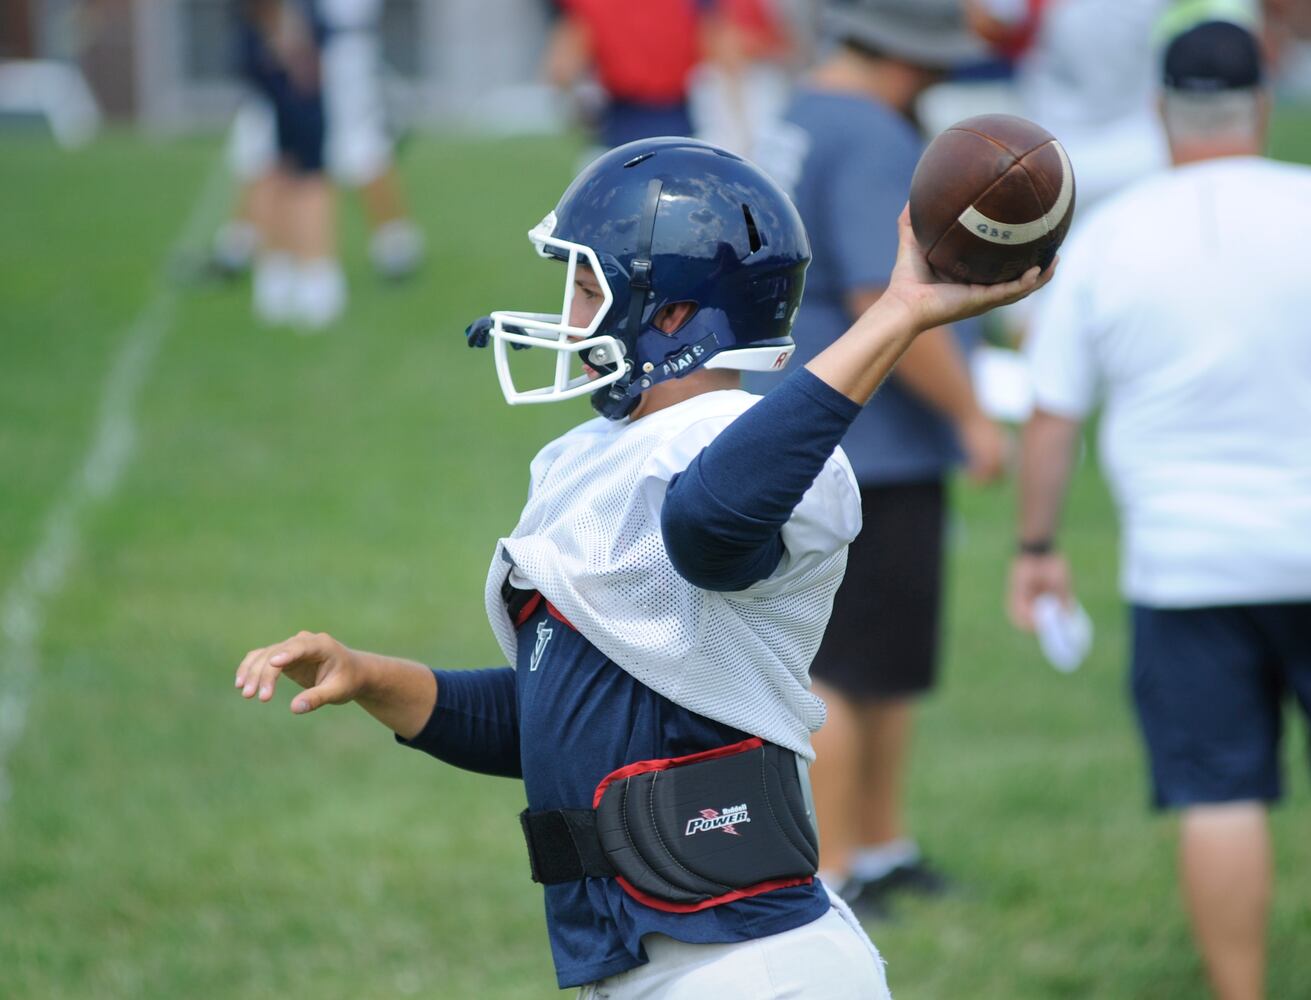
[750, 0, 1006, 916]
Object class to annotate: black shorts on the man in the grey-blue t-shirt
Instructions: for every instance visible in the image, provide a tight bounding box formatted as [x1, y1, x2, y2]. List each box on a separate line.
[810, 480, 945, 701]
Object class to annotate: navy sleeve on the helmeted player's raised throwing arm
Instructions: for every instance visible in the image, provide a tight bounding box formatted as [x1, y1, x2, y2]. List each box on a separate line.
[661, 368, 860, 591]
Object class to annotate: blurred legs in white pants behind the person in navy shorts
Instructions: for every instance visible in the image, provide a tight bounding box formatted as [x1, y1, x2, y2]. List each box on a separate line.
[212, 0, 425, 279]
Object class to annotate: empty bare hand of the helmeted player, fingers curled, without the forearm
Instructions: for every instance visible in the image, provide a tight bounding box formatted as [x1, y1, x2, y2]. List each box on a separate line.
[236, 632, 367, 716]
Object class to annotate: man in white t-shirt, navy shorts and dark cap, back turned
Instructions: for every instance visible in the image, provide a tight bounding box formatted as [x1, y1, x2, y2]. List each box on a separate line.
[1011, 13, 1311, 999]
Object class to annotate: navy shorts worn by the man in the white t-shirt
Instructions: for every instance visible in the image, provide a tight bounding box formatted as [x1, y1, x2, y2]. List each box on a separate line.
[1131, 602, 1311, 809]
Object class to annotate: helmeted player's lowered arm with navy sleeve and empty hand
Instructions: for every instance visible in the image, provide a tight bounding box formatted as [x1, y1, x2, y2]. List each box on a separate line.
[236, 632, 522, 777]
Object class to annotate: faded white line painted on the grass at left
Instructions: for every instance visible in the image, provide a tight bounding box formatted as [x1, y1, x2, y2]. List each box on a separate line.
[0, 161, 229, 811]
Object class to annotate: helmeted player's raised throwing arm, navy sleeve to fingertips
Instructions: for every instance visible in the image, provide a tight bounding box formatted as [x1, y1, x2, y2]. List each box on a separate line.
[661, 211, 1051, 591]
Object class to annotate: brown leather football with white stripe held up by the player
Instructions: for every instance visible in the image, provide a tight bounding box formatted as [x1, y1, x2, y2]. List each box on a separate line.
[910, 114, 1074, 284]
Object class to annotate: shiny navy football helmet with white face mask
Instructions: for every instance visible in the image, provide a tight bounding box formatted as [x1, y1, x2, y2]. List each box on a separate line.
[482, 138, 810, 419]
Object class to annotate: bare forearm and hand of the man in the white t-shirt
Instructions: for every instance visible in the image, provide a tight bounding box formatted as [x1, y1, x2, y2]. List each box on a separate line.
[1007, 409, 1080, 630]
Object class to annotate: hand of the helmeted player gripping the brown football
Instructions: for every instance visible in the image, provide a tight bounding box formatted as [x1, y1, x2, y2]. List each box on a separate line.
[882, 204, 1059, 330]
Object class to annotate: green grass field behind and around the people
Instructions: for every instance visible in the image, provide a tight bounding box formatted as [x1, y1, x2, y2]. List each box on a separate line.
[0, 118, 1311, 1000]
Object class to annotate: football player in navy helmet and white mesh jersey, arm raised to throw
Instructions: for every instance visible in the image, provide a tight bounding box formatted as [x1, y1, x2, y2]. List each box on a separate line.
[236, 138, 1050, 1000]
